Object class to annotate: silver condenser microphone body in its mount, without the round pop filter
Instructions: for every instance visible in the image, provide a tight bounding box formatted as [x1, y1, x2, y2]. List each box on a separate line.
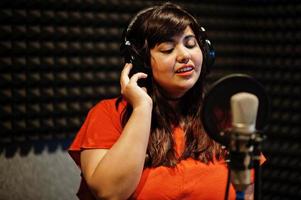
[229, 92, 259, 192]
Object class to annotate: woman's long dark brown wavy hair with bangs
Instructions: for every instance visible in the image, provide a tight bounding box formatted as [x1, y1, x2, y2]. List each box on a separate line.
[116, 3, 222, 167]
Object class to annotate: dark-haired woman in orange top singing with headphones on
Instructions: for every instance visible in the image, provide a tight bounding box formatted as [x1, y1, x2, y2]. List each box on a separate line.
[70, 3, 251, 199]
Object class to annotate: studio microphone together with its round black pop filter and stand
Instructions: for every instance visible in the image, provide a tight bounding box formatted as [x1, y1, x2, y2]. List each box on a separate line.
[201, 74, 270, 200]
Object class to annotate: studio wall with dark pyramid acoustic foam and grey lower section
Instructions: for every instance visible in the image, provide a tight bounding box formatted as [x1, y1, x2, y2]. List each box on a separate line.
[0, 0, 301, 200]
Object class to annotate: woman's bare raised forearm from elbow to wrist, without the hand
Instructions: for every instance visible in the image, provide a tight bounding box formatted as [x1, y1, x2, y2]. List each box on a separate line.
[86, 106, 151, 199]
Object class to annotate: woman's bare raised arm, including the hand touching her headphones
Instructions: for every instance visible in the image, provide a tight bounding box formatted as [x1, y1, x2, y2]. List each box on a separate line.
[81, 64, 152, 199]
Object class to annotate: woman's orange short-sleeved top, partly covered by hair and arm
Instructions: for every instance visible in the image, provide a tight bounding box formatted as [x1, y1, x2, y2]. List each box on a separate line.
[69, 99, 260, 200]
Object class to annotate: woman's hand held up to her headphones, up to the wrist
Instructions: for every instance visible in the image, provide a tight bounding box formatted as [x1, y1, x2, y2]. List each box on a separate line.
[120, 63, 152, 108]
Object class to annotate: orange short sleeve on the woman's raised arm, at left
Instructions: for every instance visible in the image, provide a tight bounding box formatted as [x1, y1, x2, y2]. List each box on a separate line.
[69, 99, 125, 166]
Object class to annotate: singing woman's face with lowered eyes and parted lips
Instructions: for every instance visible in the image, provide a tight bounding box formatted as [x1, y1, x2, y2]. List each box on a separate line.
[150, 26, 203, 98]
